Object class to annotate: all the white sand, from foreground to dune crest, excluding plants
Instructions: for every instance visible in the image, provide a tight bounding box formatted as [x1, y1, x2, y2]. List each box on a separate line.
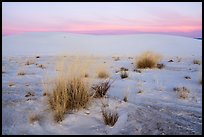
[2, 33, 202, 135]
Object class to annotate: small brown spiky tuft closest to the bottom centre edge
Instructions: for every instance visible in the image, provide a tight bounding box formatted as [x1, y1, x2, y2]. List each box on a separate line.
[102, 108, 119, 126]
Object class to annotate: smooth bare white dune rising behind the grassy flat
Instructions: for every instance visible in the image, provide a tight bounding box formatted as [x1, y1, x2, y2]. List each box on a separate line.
[2, 32, 202, 56]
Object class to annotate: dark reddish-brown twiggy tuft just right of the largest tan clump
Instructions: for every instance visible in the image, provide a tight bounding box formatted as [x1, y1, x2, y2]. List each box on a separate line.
[92, 80, 111, 98]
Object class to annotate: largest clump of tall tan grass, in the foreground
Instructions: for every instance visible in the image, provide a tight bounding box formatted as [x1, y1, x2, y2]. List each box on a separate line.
[48, 77, 89, 122]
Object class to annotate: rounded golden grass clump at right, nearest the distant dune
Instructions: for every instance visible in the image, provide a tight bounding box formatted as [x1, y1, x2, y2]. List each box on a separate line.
[135, 51, 161, 69]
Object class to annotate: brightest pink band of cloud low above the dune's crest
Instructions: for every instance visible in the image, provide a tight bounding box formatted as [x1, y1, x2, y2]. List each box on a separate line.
[3, 22, 202, 34]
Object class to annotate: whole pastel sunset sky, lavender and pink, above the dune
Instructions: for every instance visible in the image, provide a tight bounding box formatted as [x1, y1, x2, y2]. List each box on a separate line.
[2, 2, 202, 37]
